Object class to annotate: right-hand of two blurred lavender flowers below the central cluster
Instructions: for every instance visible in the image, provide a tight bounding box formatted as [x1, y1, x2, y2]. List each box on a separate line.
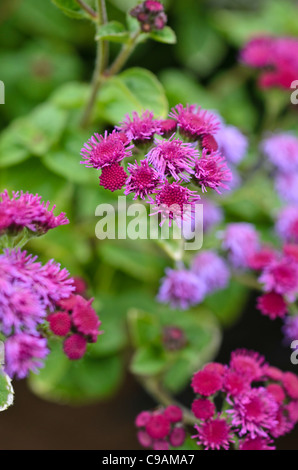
[191, 250, 230, 294]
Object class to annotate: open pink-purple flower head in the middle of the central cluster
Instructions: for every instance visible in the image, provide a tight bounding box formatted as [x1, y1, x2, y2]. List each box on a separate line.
[147, 134, 199, 181]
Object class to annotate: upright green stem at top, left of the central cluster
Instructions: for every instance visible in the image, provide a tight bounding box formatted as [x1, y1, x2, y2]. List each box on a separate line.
[81, 0, 108, 128]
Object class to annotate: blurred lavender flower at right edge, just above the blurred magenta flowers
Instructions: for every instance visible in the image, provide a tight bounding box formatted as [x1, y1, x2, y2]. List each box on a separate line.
[275, 206, 298, 243]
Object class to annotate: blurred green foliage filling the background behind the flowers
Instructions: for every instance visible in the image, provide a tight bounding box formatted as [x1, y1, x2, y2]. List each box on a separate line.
[0, 0, 298, 403]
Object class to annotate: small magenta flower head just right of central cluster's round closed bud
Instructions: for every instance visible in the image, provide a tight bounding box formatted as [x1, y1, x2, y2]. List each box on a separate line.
[124, 160, 162, 199]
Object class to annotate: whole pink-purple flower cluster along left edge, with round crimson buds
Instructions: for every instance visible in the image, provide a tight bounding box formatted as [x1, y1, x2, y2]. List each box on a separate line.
[0, 191, 100, 379]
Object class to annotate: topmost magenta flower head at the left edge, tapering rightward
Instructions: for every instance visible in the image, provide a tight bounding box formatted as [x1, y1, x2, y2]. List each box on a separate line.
[0, 190, 69, 235]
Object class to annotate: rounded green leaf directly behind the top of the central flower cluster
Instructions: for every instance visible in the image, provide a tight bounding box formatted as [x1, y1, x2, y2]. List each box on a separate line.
[96, 67, 168, 124]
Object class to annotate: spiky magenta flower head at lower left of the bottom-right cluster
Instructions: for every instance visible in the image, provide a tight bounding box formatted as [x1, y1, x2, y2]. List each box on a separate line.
[191, 418, 233, 450]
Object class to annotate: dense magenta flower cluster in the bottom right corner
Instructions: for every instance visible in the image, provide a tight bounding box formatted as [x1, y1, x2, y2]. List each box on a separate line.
[191, 350, 298, 450]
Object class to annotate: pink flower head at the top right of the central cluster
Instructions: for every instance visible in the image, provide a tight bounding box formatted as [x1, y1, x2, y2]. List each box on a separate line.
[169, 104, 220, 140]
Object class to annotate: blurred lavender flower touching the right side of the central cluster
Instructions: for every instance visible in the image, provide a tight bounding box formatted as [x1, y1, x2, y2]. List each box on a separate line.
[215, 125, 248, 165]
